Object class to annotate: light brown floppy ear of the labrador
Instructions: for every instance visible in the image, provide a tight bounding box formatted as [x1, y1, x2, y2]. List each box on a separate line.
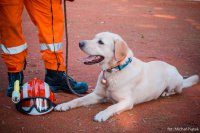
[114, 39, 128, 61]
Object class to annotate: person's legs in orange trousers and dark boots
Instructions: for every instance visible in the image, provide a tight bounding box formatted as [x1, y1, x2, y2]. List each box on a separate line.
[0, 0, 88, 96]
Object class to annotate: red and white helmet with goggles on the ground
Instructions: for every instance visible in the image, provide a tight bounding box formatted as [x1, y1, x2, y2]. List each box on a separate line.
[16, 78, 55, 115]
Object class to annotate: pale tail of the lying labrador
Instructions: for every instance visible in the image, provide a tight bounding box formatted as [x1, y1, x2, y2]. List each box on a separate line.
[182, 75, 199, 88]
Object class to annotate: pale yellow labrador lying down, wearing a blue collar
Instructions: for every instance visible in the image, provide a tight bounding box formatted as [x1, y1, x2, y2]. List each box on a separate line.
[55, 32, 199, 122]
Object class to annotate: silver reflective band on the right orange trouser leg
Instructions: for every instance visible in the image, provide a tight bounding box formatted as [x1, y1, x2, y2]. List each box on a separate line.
[40, 42, 62, 52]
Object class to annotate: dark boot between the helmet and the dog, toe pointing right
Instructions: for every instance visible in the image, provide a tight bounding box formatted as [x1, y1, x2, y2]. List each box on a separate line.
[45, 69, 88, 94]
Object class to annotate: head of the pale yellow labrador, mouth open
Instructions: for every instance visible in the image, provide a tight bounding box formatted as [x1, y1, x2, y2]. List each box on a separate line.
[79, 32, 129, 69]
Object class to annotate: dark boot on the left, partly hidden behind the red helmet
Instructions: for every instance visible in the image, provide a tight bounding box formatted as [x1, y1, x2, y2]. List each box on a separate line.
[7, 71, 24, 97]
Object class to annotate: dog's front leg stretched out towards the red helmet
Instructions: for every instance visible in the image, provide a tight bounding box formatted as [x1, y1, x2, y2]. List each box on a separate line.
[54, 92, 103, 111]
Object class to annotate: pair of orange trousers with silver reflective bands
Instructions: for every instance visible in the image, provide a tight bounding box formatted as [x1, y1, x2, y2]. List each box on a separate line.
[0, 0, 65, 72]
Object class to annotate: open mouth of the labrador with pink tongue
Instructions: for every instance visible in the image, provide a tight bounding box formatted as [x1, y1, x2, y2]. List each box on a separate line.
[81, 55, 104, 65]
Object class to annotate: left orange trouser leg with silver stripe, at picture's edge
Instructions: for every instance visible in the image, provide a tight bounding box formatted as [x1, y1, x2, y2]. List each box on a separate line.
[0, 0, 27, 72]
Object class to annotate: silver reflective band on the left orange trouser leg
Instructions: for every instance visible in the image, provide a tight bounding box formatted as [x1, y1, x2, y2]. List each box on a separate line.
[0, 43, 28, 54]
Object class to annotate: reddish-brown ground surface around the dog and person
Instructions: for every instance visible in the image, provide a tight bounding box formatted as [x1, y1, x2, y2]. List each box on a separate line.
[0, 0, 200, 133]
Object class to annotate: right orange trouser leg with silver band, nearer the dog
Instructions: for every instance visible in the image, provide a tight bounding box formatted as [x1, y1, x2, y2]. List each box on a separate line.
[24, 0, 66, 71]
